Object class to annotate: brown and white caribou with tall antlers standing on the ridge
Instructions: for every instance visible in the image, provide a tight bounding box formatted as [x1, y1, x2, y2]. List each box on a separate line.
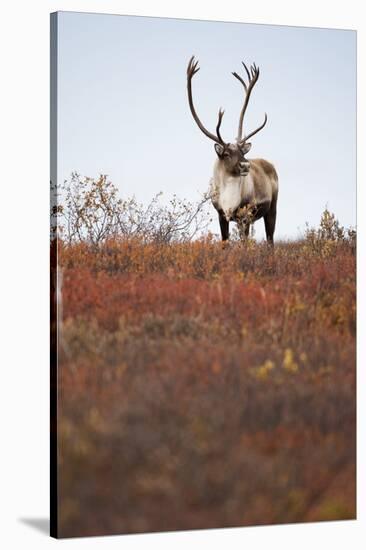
[187, 56, 278, 245]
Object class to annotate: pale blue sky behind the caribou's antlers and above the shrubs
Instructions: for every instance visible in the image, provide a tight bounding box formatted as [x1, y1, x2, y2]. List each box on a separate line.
[58, 12, 356, 238]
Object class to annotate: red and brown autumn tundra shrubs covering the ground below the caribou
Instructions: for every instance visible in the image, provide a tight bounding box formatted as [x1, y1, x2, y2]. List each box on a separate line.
[51, 174, 356, 536]
